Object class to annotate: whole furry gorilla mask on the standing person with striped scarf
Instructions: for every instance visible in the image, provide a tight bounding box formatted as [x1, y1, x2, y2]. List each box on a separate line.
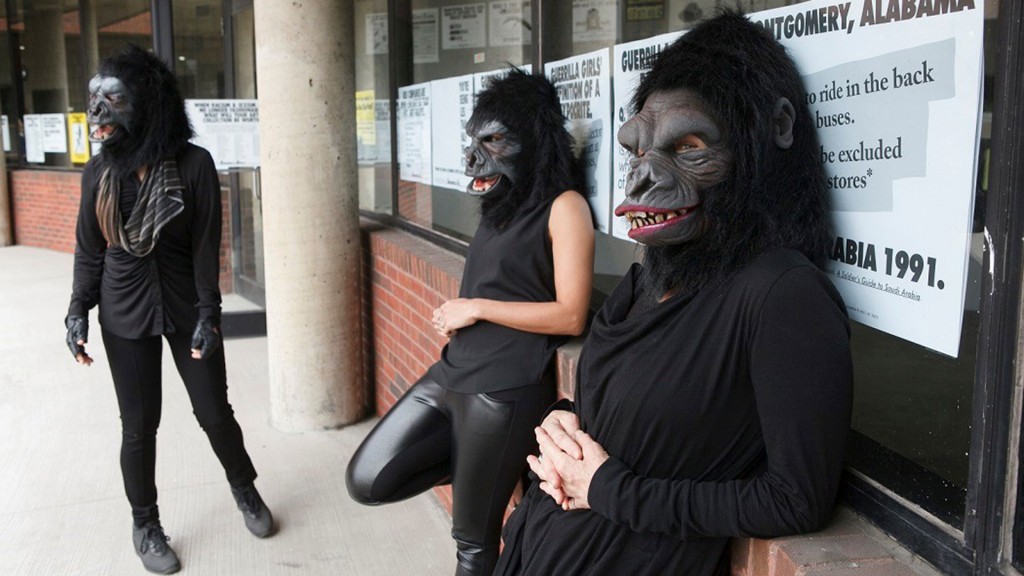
[86, 45, 193, 174]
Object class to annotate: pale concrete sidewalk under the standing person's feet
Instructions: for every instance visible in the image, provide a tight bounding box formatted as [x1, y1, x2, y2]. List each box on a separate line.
[0, 246, 456, 576]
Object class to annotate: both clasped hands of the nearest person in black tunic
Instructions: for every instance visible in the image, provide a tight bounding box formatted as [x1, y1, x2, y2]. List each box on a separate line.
[526, 410, 608, 510]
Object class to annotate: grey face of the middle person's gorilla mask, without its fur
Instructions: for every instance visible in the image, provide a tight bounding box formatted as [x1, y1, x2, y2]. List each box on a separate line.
[465, 120, 522, 196]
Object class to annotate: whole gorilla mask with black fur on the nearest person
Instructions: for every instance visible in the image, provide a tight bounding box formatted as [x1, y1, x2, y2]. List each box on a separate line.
[615, 11, 829, 305]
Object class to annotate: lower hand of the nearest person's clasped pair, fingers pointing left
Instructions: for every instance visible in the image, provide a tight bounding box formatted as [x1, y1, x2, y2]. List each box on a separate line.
[534, 427, 608, 510]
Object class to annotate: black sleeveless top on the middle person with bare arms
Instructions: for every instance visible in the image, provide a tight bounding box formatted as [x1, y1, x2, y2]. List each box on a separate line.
[428, 194, 565, 394]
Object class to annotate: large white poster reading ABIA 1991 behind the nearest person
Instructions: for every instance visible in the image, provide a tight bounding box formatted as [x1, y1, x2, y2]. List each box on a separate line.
[750, 0, 984, 357]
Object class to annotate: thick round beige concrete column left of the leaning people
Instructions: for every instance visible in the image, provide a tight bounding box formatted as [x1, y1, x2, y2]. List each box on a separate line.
[254, 0, 368, 431]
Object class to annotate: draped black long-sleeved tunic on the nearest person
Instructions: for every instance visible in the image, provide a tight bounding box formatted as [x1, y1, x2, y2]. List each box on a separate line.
[495, 250, 853, 576]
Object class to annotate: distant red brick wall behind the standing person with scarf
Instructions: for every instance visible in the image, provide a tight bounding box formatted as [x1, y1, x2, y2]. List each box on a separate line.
[8, 169, 232, 294]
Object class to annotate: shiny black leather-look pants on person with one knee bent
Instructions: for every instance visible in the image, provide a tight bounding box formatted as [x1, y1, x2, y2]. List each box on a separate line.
[345, 376, 555, 576]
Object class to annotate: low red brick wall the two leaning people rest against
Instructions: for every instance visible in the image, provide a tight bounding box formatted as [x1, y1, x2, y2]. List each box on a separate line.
[364, 221, 938, 576]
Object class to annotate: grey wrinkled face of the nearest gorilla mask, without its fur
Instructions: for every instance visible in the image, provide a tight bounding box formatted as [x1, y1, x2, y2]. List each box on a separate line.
[615, 88, 732, 246]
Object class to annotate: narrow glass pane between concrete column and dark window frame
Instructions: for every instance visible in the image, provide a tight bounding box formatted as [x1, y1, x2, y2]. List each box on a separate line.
[352, 0, 392, 213]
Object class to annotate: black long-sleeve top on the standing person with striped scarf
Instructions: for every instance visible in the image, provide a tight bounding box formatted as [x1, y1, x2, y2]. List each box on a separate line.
[68, 145, 221, 338]
